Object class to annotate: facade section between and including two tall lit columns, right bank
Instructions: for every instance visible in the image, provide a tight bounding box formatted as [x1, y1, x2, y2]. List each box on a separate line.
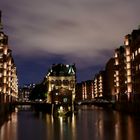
[114, 42, 132, 101]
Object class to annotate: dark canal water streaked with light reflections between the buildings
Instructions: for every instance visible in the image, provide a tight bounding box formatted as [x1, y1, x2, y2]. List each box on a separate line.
[0, 105, 140, 140]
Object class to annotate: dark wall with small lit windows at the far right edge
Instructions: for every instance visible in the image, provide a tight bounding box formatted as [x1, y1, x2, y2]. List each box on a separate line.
[129, 28, 140, 102]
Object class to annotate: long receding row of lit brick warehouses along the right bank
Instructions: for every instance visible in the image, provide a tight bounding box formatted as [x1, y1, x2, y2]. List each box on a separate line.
[77, 28, 140, 103]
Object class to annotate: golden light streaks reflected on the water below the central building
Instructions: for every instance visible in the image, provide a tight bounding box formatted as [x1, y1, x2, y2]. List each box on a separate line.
[35, 113, 76, 140]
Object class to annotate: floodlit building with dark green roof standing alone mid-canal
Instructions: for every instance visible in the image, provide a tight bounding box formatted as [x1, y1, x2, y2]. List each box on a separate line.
[45, 64, 76, 113]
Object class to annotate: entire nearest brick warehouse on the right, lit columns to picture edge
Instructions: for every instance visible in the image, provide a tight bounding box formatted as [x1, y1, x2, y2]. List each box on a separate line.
[114, 29, 140, 102]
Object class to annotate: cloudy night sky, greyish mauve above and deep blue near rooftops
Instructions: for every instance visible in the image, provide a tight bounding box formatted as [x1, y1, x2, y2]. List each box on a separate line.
[0, 0, 140, 85]
